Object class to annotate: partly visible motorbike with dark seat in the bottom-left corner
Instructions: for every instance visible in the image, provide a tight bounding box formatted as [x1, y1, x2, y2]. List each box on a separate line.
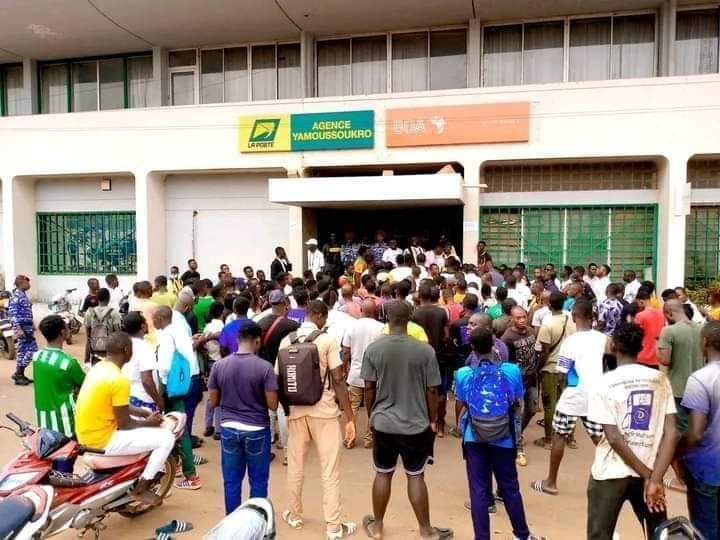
[0, 486, 55, 540]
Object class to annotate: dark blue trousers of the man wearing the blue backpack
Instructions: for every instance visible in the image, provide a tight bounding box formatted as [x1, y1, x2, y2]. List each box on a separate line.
[463, 443, 530, 540]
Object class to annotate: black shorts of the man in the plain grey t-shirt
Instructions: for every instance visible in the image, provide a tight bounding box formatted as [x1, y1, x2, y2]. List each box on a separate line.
[373, 428, 435, 476]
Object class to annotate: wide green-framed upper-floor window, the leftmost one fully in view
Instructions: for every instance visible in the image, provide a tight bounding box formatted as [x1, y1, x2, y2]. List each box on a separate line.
[40, 55, 153, 113]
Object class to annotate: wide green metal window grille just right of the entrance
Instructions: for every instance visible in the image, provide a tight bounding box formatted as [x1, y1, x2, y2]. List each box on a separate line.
[480, 205, 657, 276]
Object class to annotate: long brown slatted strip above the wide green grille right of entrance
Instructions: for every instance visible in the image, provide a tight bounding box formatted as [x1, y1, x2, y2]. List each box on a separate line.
[483, 161, 657, 193]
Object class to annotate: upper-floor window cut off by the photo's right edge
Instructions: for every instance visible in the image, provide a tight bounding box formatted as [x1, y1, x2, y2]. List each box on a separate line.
[674, 9, 720, 75]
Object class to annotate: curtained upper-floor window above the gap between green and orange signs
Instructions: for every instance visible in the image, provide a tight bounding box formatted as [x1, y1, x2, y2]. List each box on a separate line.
[317, 29, 467, 97]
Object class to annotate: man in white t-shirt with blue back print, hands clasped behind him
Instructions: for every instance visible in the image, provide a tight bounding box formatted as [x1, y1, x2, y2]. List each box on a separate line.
[587, 324, 679, 540]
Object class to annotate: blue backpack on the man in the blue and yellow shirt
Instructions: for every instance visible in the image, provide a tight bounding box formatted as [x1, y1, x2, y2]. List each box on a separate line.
[467, 359, 513, 443]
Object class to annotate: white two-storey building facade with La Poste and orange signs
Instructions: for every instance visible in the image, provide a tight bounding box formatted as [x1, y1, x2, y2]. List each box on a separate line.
[0, 0, 720, 298]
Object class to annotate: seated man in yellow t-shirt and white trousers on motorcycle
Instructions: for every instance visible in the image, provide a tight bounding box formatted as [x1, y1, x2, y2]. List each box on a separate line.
[75, 332, 175, 505]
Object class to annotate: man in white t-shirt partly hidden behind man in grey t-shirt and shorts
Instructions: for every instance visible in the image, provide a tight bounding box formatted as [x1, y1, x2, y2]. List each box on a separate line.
[342, 299, 383, 448]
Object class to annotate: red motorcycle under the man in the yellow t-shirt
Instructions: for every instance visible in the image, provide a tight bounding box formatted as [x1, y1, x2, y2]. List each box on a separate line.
[0, 413, 186, 539]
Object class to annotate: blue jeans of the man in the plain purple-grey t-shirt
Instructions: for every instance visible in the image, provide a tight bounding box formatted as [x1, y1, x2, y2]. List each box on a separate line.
[220, 427, 270, 514]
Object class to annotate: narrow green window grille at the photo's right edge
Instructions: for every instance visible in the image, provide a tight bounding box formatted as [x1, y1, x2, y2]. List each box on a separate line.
[685, 206, 720, 287]
